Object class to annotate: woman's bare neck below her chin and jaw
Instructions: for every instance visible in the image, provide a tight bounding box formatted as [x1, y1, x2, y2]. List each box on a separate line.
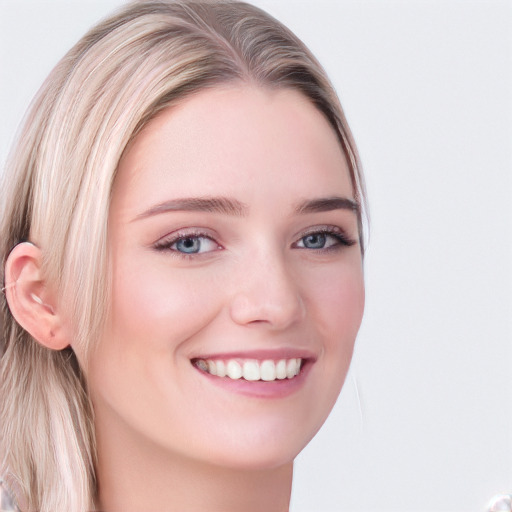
[93, 416, 293, 512]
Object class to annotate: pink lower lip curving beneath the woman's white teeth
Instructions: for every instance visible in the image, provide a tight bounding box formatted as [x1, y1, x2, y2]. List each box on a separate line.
[194, 361, 313, 398]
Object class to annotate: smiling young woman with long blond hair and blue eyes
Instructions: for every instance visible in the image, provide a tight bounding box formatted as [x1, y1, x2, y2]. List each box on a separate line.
[0, 1, 364, 512]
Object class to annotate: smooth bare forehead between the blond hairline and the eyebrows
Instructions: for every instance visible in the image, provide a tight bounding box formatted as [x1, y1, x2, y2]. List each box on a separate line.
[114, 85, 352, 213]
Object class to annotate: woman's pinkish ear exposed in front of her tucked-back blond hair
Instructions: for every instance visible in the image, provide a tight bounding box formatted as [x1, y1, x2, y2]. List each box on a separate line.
[5, 242, 70, 350]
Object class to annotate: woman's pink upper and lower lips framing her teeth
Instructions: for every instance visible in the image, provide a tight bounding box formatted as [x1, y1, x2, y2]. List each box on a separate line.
[193, 350, 316, 399]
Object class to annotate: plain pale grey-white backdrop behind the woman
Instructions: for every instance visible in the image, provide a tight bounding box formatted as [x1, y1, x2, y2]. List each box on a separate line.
[0, 0, 512, 512]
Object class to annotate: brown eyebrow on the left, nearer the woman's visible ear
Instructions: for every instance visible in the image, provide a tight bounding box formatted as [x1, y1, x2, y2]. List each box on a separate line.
[134, 197, 249, 220]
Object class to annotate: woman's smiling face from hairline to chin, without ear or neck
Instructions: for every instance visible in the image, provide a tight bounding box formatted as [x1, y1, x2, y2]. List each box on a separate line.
[84, 86, 364, 468]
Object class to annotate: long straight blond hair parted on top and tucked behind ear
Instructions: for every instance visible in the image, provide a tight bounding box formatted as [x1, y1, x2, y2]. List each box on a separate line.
[0, 0, 365, 512]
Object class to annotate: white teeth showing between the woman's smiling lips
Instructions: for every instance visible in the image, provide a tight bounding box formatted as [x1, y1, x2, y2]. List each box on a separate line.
[192, 358, 303, 382]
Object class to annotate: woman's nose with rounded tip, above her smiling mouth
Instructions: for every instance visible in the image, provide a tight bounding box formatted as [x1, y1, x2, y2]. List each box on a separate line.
[230, 249, 306, 330]
